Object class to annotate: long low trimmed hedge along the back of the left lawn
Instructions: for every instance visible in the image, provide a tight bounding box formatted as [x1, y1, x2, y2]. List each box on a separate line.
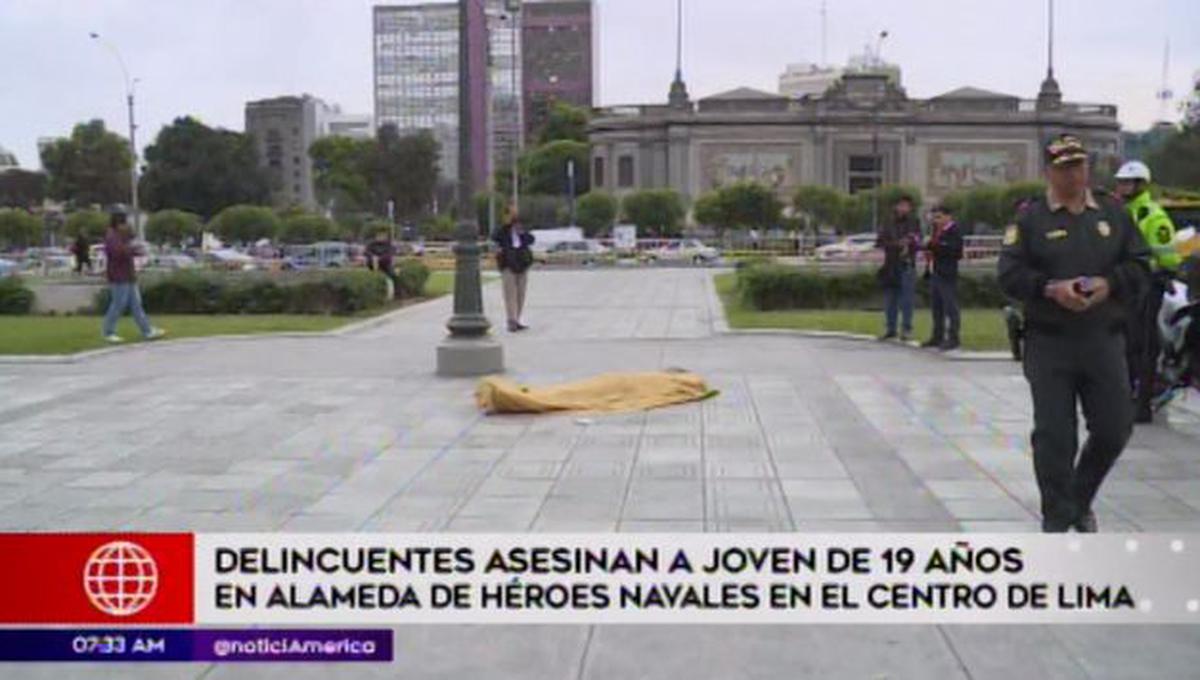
[88, 265, 428, 314]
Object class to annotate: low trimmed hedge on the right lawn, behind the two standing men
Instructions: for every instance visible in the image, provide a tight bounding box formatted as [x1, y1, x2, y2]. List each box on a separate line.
[737, 264, 1007, 311]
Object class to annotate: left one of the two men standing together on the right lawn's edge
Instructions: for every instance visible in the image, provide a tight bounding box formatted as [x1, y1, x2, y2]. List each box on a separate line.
[875, 194, 920, 342]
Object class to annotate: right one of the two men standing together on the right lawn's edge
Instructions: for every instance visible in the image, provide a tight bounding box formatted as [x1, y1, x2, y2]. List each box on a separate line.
[922, 205, 962, 351]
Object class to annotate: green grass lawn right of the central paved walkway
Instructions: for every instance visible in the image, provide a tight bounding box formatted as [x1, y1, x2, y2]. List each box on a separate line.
[716, 273, 1008, 350]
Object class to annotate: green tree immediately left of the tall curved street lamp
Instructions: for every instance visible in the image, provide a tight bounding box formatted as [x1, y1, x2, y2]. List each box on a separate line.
[41, 120, 132, 206]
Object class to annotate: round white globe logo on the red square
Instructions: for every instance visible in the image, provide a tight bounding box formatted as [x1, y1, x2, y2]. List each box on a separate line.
[83, 541, 158, 616]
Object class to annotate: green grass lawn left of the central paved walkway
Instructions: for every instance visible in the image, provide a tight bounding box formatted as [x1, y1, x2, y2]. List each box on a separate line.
[0, 271, 475, 354]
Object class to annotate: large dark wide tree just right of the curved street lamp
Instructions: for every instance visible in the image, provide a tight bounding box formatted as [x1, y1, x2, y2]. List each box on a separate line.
[138, 116, 270, 219]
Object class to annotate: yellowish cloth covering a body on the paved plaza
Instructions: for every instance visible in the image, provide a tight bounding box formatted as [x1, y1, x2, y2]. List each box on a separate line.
[475, 372, 715, 414]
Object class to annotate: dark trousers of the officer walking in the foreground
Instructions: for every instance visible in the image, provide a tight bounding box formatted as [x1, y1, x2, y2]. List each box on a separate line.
[1025, 327, 1133, 531]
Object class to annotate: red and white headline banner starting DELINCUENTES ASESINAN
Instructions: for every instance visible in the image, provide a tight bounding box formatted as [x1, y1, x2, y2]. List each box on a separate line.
[0, 534, 1200, 626]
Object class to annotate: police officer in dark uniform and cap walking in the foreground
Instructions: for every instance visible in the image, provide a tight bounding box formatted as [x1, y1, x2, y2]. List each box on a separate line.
[1000, 134, 1150, 532]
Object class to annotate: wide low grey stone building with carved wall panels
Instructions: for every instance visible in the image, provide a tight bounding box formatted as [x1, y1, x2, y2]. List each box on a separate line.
[589, 73, 1121, 208]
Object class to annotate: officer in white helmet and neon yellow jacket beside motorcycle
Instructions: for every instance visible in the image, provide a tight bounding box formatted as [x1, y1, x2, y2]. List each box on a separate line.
[1115, 161, 1183, 423]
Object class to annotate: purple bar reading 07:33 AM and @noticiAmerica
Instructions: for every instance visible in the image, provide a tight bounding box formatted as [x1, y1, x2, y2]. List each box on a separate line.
[0, 627, 394, 663]
